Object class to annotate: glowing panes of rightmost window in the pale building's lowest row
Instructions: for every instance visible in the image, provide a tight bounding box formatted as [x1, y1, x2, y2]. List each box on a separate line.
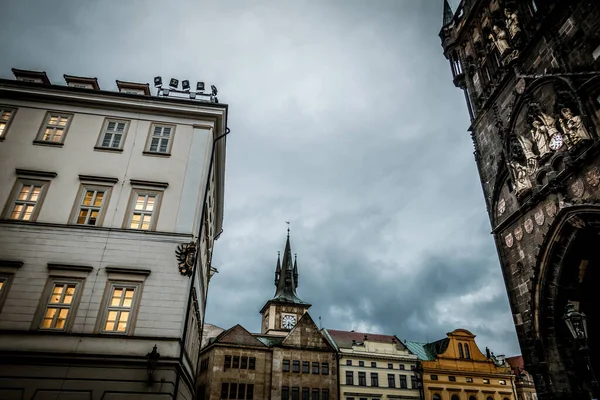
[102, 284, 139, 333]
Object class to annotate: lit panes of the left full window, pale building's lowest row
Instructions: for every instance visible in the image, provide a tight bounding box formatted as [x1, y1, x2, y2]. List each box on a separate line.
[40, 281, 80, 331]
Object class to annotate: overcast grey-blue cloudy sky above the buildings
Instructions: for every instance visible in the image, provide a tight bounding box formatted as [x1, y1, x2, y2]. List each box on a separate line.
[0, 0, 520, 355]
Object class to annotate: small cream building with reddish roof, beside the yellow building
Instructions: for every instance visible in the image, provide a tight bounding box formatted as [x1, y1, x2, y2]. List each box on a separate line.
[323, 329, 420, 400]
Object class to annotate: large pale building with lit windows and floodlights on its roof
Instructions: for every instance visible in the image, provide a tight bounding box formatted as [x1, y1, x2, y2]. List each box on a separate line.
[0, 70, 228, 400]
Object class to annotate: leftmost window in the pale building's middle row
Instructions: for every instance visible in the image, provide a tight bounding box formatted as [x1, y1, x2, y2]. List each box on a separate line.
[5, 179, 49, 222]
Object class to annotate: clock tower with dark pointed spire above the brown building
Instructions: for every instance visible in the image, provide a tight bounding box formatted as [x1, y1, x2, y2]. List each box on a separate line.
[260, 228, 311, 336]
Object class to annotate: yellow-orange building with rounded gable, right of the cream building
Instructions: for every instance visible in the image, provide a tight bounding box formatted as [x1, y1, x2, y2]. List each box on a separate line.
[405, 329, 517, 400]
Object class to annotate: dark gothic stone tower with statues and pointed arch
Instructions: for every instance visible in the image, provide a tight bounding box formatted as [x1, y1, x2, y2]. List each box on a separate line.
[440, 0, 600, 399]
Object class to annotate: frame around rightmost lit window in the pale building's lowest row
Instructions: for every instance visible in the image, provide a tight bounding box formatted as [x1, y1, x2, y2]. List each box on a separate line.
[98, 281, 142, 335]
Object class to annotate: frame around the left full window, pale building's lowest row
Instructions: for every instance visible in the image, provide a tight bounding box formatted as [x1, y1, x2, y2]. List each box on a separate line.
[34, 277, 84, 332]
